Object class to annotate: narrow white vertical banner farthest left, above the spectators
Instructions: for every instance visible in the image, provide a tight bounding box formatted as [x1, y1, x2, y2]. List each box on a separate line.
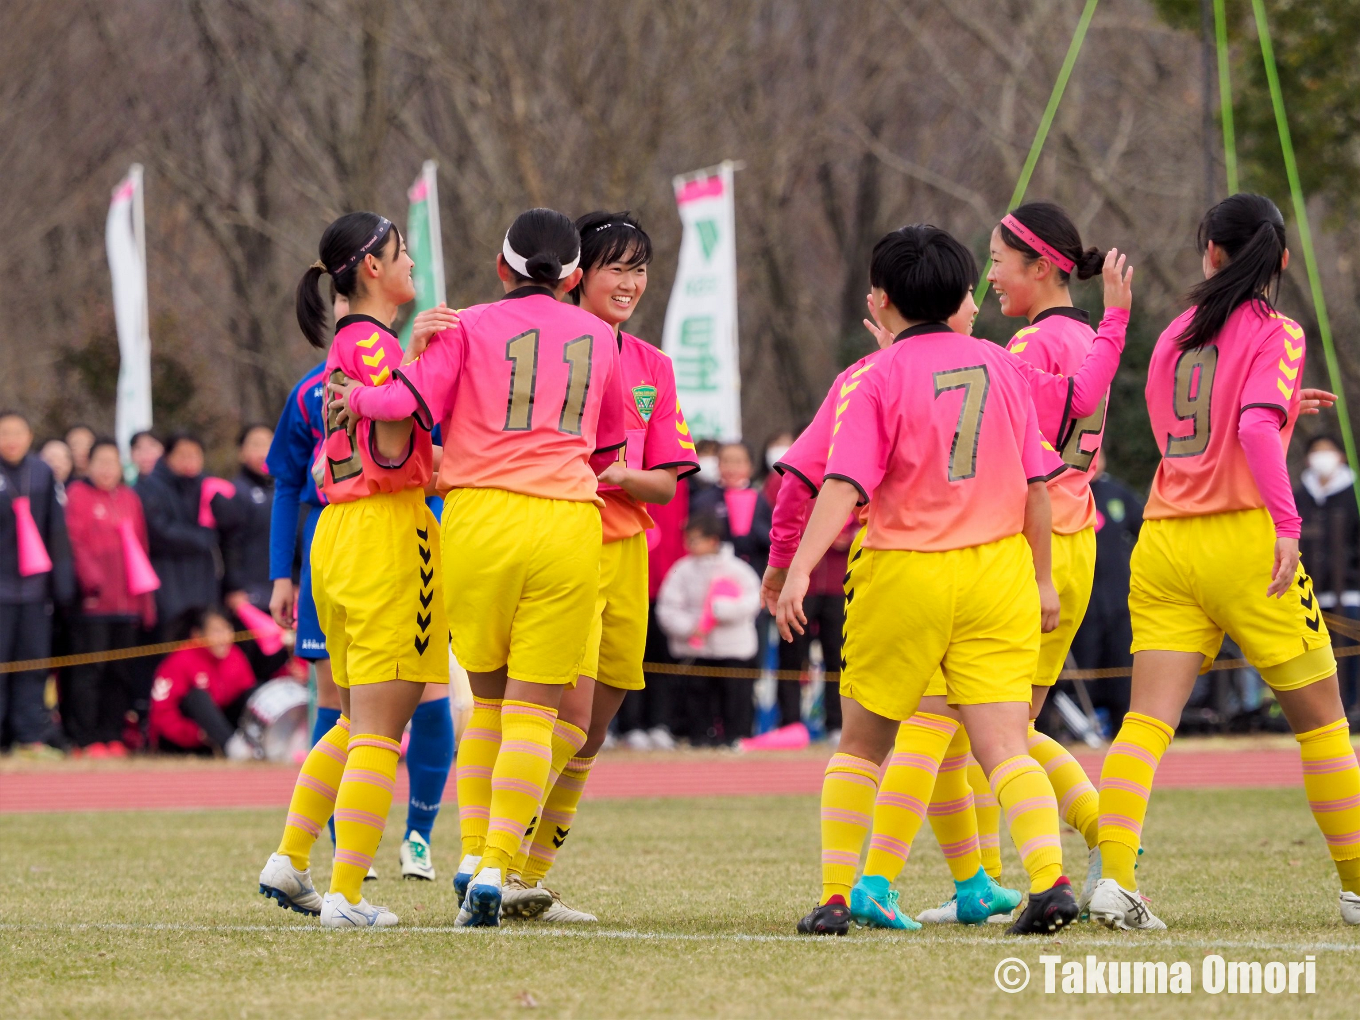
[105, 163, 151, 462]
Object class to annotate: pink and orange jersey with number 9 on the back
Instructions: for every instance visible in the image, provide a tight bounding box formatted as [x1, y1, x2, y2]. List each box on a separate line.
[1142, 302, 1304, 520]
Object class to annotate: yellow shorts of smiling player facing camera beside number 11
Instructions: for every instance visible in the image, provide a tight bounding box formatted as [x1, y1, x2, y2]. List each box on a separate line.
[581, 532, 647, 691]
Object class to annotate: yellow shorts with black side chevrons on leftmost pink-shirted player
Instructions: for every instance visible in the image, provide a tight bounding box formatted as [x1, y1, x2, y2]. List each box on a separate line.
[311, 488, 449, 687]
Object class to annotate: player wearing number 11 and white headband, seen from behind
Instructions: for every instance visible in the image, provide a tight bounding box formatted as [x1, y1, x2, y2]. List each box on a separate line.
[331, 209, 626, 926]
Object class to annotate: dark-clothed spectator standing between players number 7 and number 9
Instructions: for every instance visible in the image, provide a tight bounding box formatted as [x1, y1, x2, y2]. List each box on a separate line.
[1072, 450, 1142, 733]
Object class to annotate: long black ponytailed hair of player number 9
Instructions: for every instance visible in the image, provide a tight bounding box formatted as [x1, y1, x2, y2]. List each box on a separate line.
[1176, 192, 1285, 351]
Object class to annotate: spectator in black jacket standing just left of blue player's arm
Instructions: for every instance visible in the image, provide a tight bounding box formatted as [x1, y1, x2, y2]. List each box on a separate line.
[212, 424, 273, 612]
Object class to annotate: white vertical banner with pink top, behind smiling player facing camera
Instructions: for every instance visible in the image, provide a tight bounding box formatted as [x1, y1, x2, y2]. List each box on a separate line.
[661, 160, 741, 441]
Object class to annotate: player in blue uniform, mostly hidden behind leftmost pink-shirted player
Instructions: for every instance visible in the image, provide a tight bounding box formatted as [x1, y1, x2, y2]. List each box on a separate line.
[261, 284, 458, 886]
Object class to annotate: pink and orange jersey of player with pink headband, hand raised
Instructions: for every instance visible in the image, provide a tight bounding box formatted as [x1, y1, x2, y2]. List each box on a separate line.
[1006, 307, 1129, 534]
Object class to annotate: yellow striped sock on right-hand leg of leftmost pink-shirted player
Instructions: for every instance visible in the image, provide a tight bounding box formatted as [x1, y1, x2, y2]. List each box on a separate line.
[330, 733, 401, 903]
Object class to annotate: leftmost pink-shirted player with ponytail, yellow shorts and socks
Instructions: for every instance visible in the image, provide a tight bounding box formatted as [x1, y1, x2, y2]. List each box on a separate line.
[260, 212, 449, 928]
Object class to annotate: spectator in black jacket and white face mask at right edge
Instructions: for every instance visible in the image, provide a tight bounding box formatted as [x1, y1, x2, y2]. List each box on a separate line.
[1293, 435, 1360, 717]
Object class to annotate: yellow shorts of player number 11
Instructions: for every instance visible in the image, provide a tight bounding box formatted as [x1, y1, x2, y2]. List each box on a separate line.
[443, 488, 600, 685]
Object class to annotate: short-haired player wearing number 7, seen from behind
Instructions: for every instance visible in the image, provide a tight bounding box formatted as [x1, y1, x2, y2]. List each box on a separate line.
[777, 226, 1077, 934]
